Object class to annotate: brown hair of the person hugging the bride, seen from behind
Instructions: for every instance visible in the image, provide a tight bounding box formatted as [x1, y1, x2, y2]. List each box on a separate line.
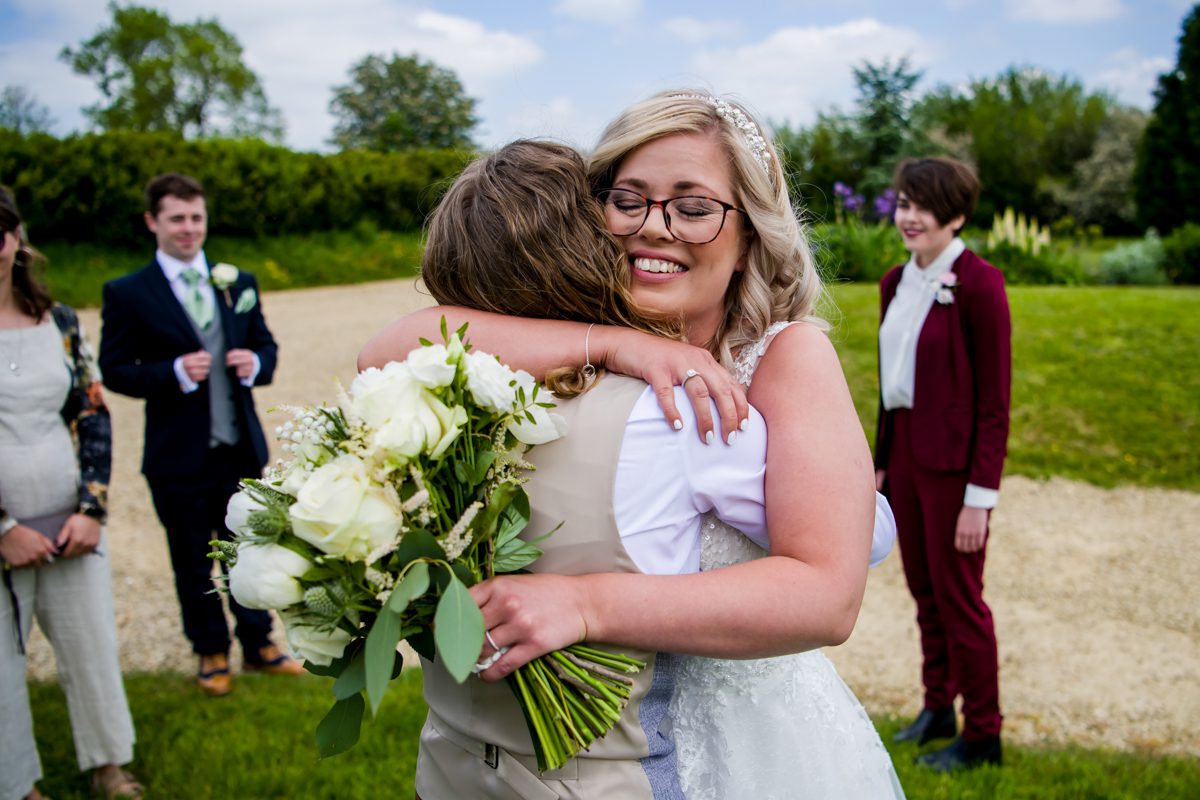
[421, 139, 679, 397]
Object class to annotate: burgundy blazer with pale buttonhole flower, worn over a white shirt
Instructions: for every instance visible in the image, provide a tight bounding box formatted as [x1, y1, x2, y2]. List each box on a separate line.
[875, 249, 1013, 489]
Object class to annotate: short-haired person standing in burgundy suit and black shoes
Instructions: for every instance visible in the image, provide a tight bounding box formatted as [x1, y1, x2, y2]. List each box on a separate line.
[875, 158, 1012, 771]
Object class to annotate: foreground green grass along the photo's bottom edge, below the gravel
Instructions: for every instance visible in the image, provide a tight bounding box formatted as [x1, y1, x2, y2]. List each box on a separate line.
[30, 670, 1200, 800]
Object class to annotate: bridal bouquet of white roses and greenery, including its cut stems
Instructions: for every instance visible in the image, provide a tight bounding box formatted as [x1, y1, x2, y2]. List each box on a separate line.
[214, 320, 644, 770]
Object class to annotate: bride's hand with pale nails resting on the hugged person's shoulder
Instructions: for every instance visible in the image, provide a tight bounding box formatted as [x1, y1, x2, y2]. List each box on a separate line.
[593, 326, 750, 444]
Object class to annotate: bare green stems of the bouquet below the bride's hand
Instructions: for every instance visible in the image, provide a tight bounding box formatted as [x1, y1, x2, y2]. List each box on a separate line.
[508, 644, 646, 771]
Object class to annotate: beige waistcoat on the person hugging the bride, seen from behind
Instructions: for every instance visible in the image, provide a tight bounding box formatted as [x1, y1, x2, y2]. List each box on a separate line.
[416, 375, 683, 800]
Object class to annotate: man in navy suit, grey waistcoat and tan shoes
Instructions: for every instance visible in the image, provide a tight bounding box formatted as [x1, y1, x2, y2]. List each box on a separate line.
[100, 173, 301, 696]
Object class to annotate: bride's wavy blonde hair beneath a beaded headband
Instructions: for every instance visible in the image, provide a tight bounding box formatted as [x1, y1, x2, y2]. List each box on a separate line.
[588, 89, 828, 367]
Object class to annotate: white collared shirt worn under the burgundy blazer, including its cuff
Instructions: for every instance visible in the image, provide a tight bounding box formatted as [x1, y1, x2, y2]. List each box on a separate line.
[880, 236, 1000, 509]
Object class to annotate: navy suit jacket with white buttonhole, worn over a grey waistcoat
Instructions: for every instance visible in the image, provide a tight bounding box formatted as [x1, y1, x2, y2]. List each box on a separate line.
[100, 260, 277, 479]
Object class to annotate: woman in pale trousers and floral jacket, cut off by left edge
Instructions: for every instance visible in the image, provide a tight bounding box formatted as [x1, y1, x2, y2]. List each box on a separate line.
[0, 190, 142, 800]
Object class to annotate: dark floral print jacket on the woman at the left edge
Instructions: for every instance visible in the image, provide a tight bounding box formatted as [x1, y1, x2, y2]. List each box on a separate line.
[0, 303, 113, 523]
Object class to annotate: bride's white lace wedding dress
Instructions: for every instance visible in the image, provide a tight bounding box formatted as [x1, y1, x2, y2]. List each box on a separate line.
[670, 323, 904, 800]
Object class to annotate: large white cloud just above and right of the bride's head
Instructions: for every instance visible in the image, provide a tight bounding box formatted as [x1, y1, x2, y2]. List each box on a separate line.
[692, 18, 932, 124]
